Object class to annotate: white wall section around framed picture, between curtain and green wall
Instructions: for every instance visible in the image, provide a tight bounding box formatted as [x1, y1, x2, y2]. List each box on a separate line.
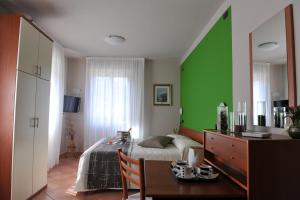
[145, 60, 180, 137]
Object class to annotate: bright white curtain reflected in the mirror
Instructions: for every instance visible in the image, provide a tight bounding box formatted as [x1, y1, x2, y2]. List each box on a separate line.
[253, 63, 272, 126]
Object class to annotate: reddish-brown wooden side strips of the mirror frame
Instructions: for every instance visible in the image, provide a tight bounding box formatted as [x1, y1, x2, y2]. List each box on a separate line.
[249, 4, 297, 126]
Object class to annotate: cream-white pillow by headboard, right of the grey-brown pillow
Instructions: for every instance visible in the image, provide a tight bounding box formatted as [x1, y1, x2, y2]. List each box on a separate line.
[168, 134, 203, 160]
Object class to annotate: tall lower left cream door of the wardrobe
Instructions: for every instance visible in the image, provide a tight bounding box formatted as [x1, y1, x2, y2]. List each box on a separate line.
[12, 72, 36, 200]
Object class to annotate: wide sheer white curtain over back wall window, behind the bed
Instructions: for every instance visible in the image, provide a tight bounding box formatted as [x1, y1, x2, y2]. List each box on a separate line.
[84, 57, 145, 149]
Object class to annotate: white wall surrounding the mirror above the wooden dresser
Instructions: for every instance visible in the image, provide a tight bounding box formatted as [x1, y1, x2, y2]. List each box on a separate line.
[231, 0, 300, 131]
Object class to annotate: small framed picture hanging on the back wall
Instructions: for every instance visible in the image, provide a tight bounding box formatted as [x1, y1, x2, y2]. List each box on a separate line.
[153, 84, 172, 106]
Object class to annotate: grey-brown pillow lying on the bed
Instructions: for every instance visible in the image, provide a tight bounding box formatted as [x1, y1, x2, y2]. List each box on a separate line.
[138, 136, 173, 149]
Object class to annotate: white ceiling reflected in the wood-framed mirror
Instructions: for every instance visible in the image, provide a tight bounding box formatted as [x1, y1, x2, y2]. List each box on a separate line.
[253, 10, 287, 64]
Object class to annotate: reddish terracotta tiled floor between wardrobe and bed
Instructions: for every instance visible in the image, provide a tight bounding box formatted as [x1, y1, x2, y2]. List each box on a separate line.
[33, 158, 125, 200]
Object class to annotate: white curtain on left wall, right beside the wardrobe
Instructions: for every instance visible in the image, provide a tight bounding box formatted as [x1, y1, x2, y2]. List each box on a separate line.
[48, 43, 65, 169]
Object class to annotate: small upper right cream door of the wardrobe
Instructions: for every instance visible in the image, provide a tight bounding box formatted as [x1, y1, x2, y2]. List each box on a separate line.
[38, 33, 52, 80]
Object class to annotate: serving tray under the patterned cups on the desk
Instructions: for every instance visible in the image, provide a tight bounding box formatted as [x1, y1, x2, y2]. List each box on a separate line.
[170, 165, 219, 182]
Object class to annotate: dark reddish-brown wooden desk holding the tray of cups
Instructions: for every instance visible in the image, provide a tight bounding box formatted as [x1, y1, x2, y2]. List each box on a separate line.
[145, 160, 247, 200]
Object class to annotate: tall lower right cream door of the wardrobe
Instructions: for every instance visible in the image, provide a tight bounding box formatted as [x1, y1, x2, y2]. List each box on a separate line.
[33, 78, 50, 193]
